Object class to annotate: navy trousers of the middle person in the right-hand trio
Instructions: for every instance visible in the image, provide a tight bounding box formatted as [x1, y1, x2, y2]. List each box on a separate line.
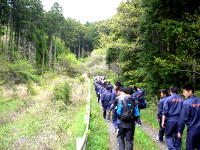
[165, 121, 181, 150]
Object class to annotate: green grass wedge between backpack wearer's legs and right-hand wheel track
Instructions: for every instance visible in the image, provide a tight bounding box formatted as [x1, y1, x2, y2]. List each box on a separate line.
[134, 127, 159, 150]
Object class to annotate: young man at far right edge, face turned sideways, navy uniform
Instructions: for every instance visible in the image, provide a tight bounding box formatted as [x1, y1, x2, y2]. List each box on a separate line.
[178, 85, 200, 150]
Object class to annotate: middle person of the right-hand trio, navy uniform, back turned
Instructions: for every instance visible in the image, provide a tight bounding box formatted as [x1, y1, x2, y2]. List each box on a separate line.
[162, 86, 184, 150]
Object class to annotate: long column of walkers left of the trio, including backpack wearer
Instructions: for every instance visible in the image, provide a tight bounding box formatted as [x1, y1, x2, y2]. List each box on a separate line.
[94, 76, 146, 150]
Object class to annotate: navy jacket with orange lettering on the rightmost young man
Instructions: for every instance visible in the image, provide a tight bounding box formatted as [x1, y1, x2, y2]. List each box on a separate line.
[178, 95, 200, 133]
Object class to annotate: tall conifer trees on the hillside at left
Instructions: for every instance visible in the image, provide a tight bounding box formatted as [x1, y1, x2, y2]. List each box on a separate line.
[0, 0, 97, 83]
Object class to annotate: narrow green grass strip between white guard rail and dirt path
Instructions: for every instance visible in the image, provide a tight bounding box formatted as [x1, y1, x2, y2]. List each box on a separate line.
[86, 83, 109, 150]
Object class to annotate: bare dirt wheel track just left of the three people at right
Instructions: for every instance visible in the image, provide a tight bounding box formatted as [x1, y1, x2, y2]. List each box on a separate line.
[141, 122, 168, 150]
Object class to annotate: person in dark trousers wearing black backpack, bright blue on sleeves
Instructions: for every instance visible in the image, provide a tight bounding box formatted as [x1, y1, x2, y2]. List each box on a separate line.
[117, 87, 140, 150]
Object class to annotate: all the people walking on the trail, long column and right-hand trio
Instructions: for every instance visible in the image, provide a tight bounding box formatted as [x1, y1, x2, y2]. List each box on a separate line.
[94, 76, 200, 150]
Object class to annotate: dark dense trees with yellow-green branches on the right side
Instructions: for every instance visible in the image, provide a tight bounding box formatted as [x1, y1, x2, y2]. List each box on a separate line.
[98, 0, 200, 95]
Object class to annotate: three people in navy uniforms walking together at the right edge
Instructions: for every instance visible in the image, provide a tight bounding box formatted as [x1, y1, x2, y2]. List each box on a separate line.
[157, 85, 200, 150]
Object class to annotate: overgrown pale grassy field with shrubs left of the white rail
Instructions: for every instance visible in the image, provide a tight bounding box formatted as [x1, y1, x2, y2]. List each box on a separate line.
[0, 73, 89, 150]
